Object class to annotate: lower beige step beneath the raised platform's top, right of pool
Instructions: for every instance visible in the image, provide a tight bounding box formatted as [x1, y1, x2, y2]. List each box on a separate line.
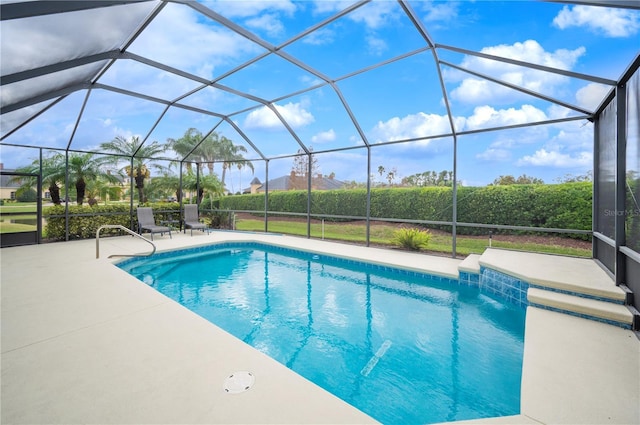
[527, 288, 634, 329]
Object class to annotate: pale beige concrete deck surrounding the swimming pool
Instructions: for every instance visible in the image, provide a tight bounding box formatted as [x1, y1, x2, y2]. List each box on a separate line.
[0, 232, 640, 424]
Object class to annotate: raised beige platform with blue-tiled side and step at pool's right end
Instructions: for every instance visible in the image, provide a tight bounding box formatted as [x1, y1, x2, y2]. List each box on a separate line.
[458, 249, 640, 330]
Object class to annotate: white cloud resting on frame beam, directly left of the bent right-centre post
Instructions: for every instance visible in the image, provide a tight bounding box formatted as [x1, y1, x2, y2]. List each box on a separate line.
[372, 112, 458, 143]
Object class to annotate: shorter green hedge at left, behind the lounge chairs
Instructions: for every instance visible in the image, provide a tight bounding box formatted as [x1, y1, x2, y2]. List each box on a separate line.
[43, 203, 180, 240]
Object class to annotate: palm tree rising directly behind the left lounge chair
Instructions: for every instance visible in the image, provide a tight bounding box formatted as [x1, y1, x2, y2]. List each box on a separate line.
[100, 136, 166, 204]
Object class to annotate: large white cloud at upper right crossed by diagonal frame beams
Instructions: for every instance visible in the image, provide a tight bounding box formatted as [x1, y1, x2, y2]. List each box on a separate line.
[445, 40, 586, 104]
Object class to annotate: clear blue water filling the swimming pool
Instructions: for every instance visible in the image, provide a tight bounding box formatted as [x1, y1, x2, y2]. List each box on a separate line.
[119, 243, 525, 424]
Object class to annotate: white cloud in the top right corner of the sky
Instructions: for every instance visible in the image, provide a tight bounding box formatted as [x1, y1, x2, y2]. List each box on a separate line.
[553, 6, 640, 37]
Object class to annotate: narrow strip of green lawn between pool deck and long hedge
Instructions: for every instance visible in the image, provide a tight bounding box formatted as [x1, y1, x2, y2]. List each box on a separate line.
[236, 218, 591, 257]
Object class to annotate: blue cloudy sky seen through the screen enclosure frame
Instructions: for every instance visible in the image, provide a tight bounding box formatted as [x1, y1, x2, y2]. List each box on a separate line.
[1, 0, 640, 191]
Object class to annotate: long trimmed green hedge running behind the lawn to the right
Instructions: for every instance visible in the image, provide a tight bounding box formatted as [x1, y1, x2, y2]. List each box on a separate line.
[220, 182, 592, 234]
